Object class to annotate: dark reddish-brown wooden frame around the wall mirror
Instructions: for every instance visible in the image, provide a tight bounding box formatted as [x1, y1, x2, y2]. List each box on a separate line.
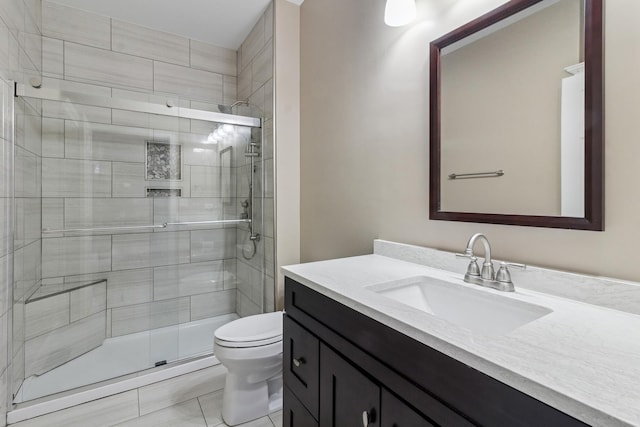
[429, 0, 604, 231]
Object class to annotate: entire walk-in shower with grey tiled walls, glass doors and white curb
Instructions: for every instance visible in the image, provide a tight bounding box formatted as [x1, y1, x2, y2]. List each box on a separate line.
[0, 0, 275, 424]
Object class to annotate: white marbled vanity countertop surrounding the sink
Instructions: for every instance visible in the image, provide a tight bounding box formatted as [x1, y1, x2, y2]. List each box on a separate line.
[283, 255, 640, 427]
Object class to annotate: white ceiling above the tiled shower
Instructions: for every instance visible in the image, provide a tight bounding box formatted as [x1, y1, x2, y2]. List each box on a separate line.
[51, 0, 282, 50]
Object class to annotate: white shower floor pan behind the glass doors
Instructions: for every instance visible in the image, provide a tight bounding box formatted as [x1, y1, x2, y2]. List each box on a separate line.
[14, 313, 238, 404]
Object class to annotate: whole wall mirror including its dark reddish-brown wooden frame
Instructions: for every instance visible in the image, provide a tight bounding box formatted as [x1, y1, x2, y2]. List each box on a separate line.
[429, 0, 604, 230]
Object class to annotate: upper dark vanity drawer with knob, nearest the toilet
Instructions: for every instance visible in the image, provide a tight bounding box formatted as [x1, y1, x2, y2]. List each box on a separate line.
[283, 315, 320, 419]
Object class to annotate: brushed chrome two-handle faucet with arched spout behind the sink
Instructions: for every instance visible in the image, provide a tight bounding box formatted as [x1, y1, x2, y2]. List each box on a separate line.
[456, 233, 526, 292]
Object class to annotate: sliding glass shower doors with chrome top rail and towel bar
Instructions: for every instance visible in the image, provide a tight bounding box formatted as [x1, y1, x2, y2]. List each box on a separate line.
[6, 78, 273, 410]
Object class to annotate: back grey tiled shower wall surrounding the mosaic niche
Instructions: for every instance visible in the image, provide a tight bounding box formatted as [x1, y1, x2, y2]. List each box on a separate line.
[41, 1, 245, 345]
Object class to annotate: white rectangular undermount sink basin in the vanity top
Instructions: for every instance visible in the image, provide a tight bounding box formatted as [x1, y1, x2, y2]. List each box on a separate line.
[368, 276, 552, 336]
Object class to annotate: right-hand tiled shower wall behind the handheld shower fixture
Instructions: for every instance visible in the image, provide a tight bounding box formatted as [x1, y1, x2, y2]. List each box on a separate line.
[236, 3, 275, 316]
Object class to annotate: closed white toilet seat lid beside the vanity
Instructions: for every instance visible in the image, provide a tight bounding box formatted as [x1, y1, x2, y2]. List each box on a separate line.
[214, 311, 282, 345]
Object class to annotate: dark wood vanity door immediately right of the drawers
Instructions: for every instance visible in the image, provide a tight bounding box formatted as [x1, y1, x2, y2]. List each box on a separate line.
[320, 343, 380, 427]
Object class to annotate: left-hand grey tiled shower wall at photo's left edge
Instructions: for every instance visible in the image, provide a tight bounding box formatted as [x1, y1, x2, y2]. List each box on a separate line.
[0, 0, 42, 426]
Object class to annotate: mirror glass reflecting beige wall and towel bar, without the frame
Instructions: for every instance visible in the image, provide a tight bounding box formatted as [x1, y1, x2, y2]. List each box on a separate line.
[440, 0, 585, 217]
